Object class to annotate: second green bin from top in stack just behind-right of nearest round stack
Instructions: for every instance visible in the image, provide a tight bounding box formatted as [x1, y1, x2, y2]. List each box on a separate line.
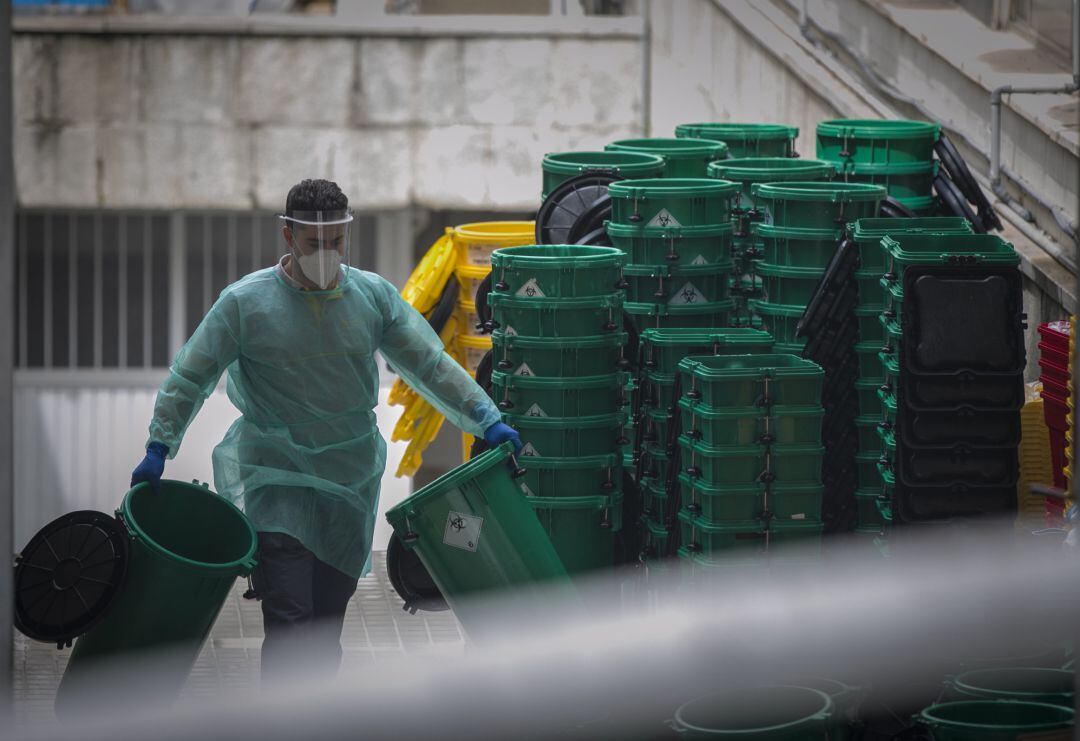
[607, 221, 734, 270]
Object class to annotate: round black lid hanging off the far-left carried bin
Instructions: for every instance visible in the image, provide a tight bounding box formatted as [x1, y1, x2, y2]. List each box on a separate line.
[14, 510, 129, 648]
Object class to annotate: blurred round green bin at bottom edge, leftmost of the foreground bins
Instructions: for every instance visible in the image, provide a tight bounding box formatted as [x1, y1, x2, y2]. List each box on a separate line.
[671, 685, 833, 741]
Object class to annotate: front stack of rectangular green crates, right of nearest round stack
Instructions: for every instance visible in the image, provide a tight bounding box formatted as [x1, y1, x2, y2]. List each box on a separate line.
[678, 354, 825, 565]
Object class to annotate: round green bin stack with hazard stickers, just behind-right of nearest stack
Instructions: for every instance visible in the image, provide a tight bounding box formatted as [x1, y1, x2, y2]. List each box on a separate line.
[607, 177, 739, 331]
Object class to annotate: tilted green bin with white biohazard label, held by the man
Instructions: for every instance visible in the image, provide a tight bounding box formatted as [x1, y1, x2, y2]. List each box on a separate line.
[387, 443, 575, 637]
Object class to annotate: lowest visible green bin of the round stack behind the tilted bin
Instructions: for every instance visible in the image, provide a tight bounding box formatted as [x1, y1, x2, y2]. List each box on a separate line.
[525, 494, 622, 574]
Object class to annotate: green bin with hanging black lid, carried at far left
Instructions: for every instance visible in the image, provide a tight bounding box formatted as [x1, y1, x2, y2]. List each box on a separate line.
[15, 480, 257, 716]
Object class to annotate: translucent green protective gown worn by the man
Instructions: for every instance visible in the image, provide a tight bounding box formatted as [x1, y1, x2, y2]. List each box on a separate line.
[150, 268, 501, 578]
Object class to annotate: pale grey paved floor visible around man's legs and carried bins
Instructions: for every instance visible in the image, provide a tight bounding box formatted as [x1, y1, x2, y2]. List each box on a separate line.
[15, 552, 464, 725]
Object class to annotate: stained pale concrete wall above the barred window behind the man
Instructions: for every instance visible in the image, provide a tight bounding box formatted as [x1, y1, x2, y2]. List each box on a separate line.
[14, 31, 643, 210]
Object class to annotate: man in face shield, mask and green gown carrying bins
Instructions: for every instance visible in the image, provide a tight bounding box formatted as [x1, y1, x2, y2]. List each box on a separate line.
[132, 179, 521, 684]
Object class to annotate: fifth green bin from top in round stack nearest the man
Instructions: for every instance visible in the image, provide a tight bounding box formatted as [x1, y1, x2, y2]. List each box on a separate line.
[503, 409, 626, 458]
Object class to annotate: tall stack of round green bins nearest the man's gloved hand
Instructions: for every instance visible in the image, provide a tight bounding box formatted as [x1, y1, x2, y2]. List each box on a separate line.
[488, 245, 626, 574]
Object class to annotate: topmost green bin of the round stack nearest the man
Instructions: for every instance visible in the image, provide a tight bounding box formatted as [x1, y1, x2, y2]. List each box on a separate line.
[491, 244, 626, 300]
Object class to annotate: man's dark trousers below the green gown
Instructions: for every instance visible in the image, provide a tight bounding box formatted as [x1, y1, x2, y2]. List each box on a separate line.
[252, 533, 356, 684]
